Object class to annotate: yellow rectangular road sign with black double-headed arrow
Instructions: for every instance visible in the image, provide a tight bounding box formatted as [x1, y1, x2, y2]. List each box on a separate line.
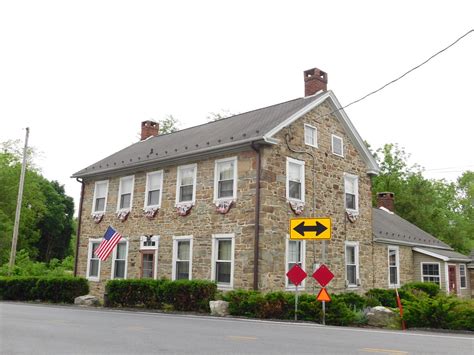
[290, 217, 331, 240]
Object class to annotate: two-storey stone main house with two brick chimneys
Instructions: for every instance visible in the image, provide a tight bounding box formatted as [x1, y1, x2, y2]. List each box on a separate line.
[73, 68, 379, 296]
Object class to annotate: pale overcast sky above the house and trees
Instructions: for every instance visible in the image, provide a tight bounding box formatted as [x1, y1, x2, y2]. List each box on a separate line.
[0, 0, 474, 214]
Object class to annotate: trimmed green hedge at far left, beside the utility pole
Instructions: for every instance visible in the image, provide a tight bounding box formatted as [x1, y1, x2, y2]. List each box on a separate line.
[0, 277, 89, 303]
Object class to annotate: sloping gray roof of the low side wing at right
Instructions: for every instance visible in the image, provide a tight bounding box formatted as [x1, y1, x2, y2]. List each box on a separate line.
[372, 208, 452, 250]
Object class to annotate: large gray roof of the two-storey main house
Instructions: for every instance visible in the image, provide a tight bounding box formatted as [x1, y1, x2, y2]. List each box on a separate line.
[72, 92, 324, 177]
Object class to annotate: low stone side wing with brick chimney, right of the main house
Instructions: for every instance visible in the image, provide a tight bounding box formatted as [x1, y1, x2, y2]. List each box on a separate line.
[372, 192, 472, 298]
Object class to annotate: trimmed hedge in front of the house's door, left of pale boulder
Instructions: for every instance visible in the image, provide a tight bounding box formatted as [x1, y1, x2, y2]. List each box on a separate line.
[106, 280, 217, 312]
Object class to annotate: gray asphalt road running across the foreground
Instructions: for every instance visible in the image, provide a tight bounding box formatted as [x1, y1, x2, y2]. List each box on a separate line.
[0, 302, 474, 355]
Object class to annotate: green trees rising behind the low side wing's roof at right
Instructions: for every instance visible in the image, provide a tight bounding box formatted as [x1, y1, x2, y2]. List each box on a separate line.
[372, 144, 473, 253]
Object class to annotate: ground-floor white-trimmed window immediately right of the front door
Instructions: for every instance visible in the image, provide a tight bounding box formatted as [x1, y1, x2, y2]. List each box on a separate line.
[171, 236, 193, 280]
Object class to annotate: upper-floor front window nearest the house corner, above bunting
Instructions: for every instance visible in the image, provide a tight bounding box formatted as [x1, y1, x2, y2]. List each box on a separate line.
[214, 157, 237, 201]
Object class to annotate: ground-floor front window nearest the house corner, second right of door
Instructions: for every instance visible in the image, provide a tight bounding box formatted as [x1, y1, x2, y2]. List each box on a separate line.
[211, 234, 235, 289]
